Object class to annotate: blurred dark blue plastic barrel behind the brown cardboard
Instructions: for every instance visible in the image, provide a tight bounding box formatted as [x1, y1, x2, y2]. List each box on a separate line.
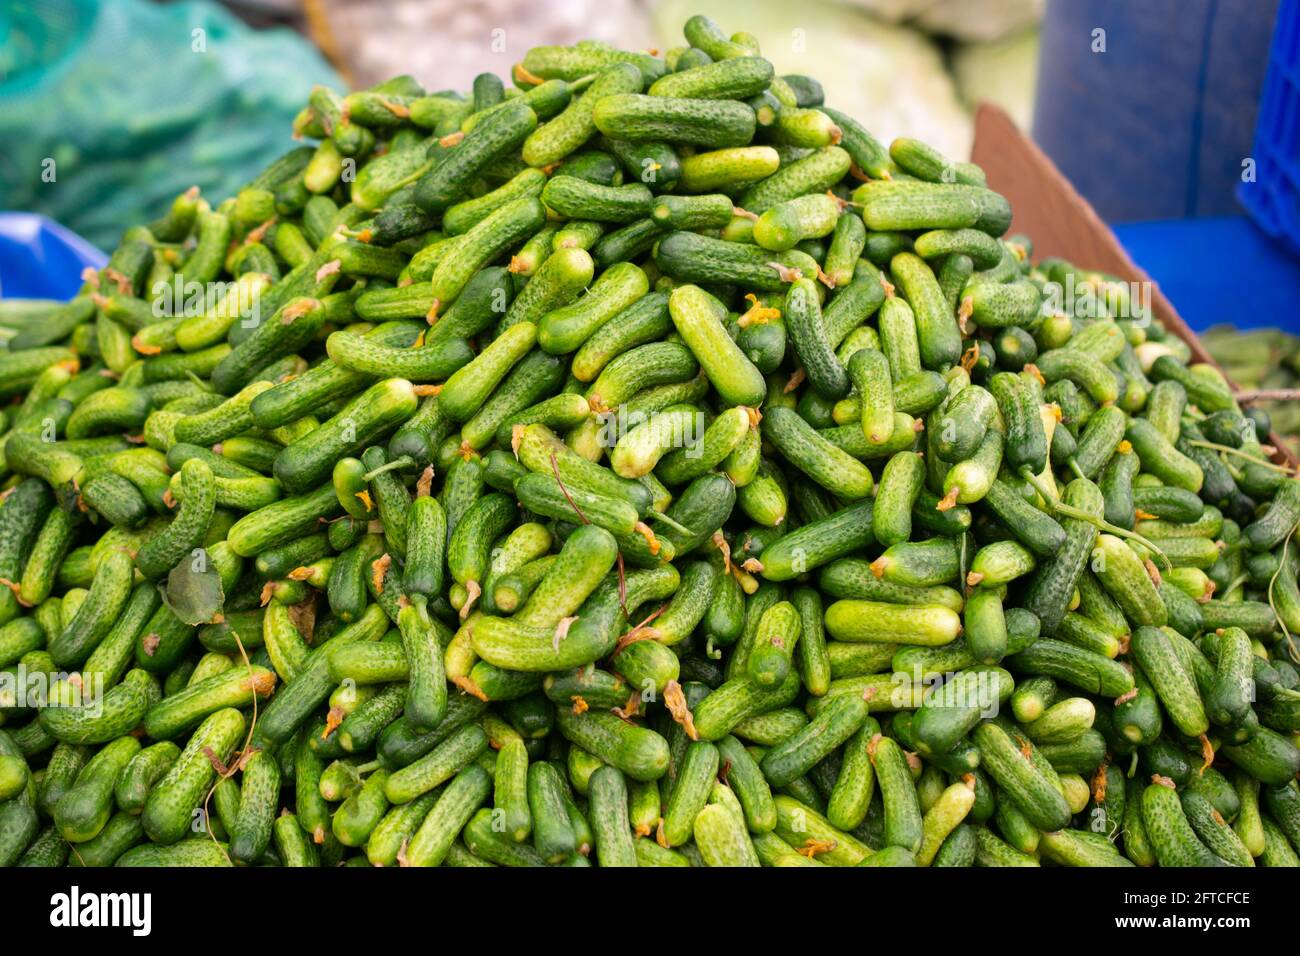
[1034, 0, 1279, 224]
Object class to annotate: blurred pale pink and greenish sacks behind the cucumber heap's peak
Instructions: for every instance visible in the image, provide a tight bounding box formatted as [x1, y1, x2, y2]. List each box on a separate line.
[314, 0, 1044, 156]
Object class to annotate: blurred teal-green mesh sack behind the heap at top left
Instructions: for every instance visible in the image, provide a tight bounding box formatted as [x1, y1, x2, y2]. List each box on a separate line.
[0, 0, 341, 248]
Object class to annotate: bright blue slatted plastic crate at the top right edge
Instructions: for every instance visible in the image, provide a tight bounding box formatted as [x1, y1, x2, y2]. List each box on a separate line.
[1236, 0, 1300, 254]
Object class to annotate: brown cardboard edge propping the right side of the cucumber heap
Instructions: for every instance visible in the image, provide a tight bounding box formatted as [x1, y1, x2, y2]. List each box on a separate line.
[971, 103, 1297, 466]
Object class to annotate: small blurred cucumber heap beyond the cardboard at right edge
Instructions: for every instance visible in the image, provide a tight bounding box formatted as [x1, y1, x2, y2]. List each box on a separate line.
[1201, 325, 1300, 455]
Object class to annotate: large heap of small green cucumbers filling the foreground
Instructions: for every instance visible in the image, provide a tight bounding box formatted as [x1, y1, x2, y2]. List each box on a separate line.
[0, 17, 1300, 866]
